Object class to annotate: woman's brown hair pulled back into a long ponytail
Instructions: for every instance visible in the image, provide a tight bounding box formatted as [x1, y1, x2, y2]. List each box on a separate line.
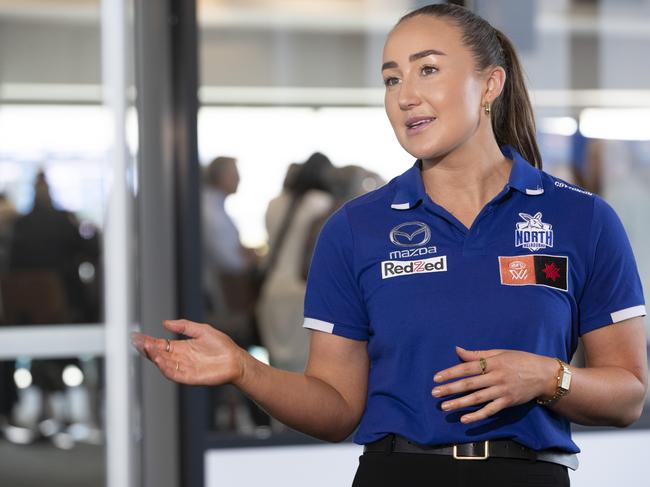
[397, 4, 542, 169]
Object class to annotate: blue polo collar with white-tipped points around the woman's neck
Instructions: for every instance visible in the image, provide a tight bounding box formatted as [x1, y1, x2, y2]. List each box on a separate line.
[390, 145, 544, 210]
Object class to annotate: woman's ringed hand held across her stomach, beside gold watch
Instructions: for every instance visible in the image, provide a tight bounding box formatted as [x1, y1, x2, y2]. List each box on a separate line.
[432, 347, 557, 423]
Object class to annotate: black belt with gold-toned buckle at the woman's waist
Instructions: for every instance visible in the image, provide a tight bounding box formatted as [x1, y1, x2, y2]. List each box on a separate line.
[363, 434, 578, 470]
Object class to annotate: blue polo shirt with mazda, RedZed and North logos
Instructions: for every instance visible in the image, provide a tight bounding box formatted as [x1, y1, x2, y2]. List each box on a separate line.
[303, 146, 645, 453]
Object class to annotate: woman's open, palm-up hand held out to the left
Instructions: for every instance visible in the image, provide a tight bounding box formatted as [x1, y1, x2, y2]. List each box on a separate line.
[131, 320, 246, 385]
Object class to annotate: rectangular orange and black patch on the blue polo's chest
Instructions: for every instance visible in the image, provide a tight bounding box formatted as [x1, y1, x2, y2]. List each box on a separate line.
[499, 254, 569, 291]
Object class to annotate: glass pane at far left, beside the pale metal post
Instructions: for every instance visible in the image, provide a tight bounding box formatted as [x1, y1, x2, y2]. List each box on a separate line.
[0, 0, 107, 486]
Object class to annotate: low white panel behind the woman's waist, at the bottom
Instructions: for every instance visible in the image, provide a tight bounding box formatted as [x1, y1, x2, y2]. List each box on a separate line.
[205, 430, 650, 487]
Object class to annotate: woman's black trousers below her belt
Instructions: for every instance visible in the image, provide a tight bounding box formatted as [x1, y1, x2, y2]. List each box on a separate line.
[352, 452, 569, 487]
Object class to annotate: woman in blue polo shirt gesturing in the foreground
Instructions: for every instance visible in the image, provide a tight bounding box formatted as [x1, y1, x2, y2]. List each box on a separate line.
[132, 5, 647, 486]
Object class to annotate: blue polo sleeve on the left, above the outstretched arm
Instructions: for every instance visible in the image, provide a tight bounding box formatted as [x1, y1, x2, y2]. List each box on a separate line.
[303, 207, 369, 340]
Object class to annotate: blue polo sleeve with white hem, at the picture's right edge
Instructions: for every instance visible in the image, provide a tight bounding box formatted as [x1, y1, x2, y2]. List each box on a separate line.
[578, 197, 646, 336]
